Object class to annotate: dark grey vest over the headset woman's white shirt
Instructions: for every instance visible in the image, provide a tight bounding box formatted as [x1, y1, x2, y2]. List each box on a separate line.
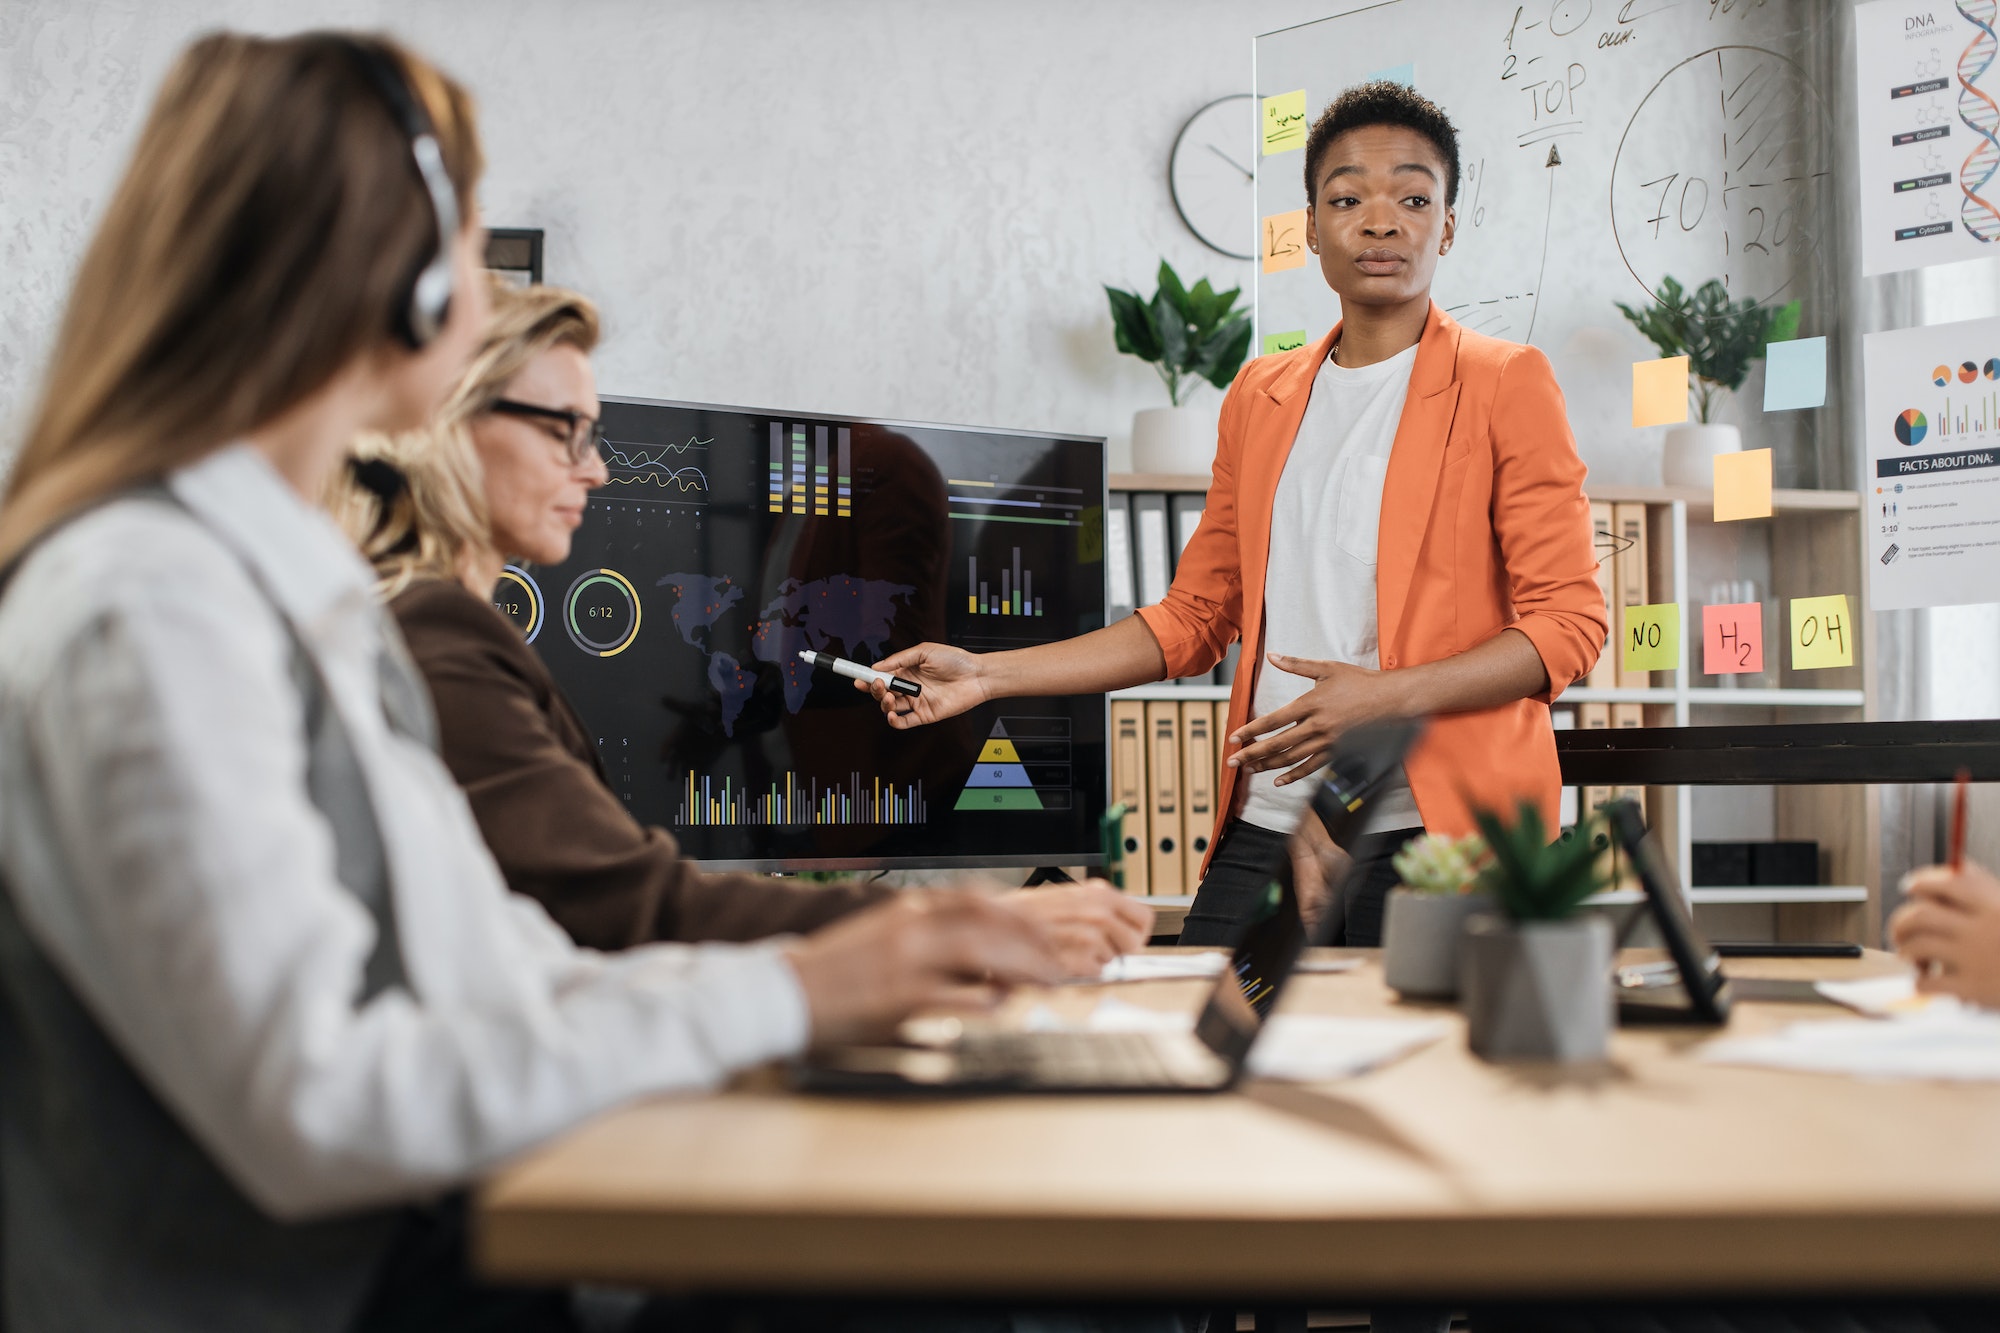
[0, 488, 436, 1333]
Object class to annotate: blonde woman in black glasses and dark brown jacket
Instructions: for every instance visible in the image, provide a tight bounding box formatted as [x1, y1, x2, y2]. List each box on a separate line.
[334, 286, 1152, 975]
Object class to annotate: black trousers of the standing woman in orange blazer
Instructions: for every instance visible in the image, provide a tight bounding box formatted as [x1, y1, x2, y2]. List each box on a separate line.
[1180, 819, 1424, 949]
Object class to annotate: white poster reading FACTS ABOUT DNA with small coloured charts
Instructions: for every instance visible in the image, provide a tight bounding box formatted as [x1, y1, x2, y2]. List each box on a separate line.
[1862, 320, 2000, 610]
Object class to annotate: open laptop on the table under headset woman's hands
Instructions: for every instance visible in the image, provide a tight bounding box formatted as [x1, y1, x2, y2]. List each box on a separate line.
[794, 721, 1422, 1095]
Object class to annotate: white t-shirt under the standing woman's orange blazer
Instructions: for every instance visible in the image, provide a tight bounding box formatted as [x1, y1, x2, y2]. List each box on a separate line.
[1242, 346, 1424, 833]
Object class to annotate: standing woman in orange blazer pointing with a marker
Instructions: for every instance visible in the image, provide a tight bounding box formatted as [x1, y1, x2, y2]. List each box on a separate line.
[862, 82, 1606, 945]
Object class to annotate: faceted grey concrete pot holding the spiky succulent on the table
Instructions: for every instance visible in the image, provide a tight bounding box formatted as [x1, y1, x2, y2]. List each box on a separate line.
[1458, 915, 1612, 1061]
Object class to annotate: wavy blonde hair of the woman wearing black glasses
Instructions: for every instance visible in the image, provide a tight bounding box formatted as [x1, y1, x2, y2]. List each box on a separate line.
[328, 282, 598, 596]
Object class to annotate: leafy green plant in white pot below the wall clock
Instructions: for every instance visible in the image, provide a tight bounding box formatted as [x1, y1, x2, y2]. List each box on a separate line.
[1104, 260, 1250, 472]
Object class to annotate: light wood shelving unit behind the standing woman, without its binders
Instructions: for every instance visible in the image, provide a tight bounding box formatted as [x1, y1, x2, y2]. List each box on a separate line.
[1110, 472, 1880, 943]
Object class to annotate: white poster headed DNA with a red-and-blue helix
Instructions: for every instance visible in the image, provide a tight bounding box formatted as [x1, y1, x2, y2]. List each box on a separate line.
[1854, 0, 2000, 276]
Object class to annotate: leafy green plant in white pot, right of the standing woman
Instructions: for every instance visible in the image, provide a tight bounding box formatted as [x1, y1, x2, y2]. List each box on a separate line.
[1612, 278, 1798, 488]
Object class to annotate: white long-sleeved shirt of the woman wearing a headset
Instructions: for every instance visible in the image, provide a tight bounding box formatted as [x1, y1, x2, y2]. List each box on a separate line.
[0, 444, 808, 1217]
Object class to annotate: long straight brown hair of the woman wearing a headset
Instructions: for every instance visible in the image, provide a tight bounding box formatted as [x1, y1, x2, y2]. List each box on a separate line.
[0, 32, 482, 564]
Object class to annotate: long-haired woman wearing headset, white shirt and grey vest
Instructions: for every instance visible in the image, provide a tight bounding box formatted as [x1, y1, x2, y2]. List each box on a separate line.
[0, 34, 1060, 1333]
